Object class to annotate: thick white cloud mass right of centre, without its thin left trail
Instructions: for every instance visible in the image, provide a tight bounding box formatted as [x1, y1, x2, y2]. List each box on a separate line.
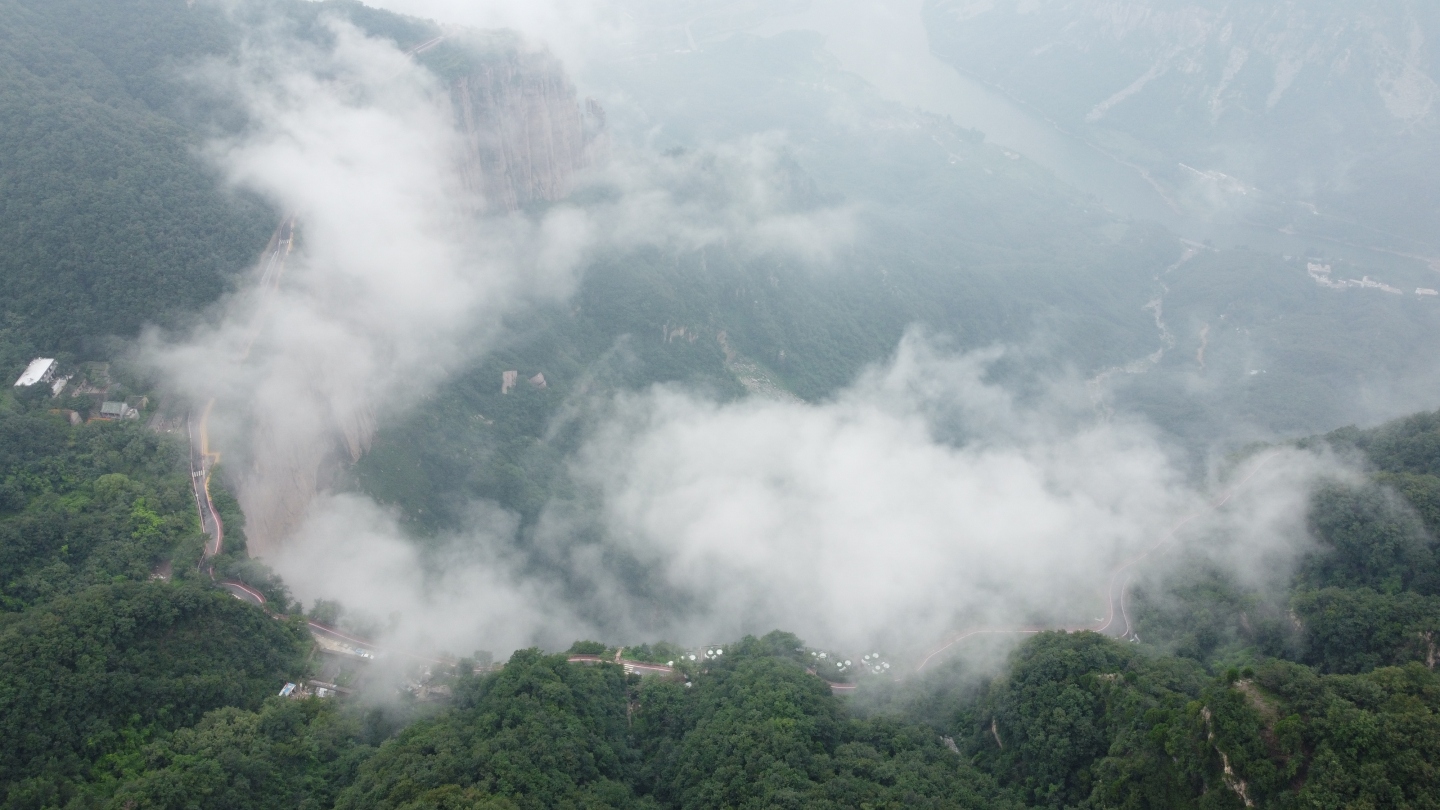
[544, 334, 1318, 647]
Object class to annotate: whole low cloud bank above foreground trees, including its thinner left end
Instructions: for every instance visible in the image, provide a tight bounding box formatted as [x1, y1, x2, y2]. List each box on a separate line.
[267, 336, 1332, 653]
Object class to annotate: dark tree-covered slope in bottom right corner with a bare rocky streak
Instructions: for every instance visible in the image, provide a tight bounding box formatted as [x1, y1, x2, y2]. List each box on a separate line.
[936, 633, 1440, 809]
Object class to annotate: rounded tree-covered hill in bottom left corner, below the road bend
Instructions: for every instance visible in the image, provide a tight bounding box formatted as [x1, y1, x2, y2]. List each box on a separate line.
[0, 582, 307, 801]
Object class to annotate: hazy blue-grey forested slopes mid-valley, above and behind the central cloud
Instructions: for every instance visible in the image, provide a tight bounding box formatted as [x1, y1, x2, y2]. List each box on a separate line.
[353, 25, 1440, 533]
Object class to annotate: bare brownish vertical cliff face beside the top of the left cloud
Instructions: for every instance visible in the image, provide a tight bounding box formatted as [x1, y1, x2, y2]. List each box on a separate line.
[451, 49, 606, 210]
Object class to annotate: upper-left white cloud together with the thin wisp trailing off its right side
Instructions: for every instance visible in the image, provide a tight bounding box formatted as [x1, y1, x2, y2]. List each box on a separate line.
[147, 12, 852, 556]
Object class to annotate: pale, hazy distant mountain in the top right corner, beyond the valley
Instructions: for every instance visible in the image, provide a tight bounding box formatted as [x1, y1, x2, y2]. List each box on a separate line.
[926, 0, 1440, 249]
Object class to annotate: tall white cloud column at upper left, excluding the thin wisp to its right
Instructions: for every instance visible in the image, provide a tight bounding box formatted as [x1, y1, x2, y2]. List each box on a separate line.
[151, 22, 589, 553]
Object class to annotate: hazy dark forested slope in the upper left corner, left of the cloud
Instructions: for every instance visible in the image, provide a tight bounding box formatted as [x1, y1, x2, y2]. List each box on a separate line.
[0, 0, 433, 373]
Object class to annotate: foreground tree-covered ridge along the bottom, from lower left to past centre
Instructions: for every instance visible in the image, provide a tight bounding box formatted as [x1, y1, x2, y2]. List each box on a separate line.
[114, 633, 1020, 810]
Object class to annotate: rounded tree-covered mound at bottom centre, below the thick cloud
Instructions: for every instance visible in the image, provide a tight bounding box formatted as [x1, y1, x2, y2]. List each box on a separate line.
[635, 633, 1020, 809]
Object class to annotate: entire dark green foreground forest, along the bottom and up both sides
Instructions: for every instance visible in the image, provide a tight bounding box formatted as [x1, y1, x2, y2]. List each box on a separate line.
[0, 397, 1440, 810]
